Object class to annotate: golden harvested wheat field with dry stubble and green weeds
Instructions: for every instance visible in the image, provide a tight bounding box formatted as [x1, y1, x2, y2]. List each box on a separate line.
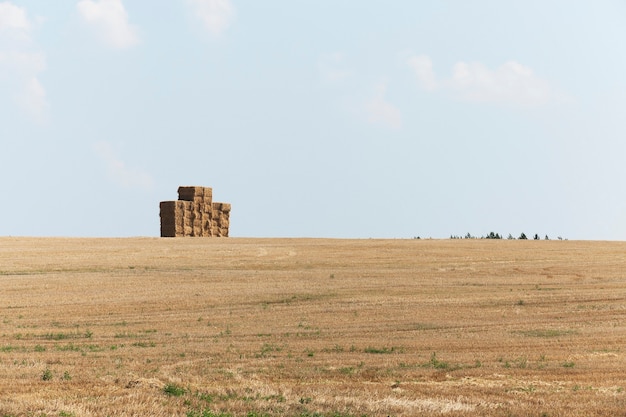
[0, 237, 626, 417]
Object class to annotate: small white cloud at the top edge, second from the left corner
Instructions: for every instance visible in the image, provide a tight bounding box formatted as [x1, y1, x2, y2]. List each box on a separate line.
[76, 0, 139, 49]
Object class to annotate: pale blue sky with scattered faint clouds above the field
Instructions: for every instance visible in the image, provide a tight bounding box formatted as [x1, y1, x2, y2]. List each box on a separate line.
[0, 0, 626, 240]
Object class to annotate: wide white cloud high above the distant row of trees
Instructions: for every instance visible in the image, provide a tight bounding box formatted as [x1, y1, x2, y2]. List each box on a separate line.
[408, 55, 557, 107]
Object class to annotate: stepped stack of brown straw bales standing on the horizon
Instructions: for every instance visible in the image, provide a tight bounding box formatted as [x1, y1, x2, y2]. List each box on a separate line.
[160, 187, 231, 237]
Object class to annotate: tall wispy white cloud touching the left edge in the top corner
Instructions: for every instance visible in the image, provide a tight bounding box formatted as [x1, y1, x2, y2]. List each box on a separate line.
[0, 1, 48, 121]
